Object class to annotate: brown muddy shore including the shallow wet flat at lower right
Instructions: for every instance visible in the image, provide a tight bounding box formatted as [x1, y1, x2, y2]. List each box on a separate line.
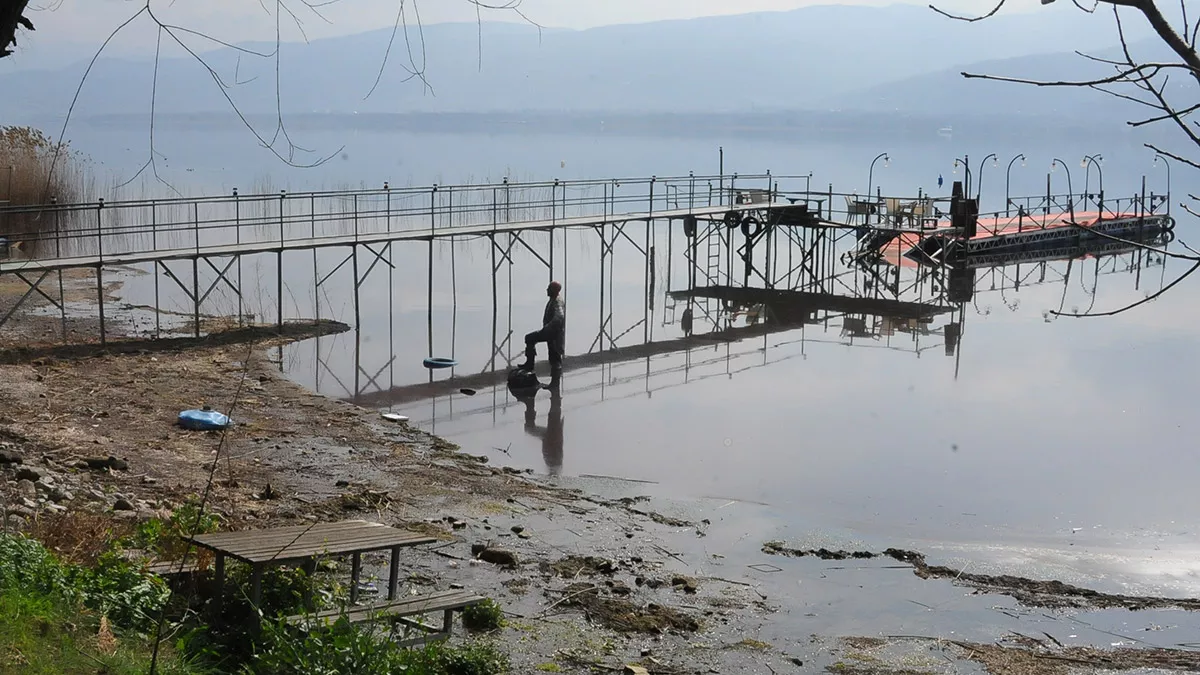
[0, 266, 1200, 674]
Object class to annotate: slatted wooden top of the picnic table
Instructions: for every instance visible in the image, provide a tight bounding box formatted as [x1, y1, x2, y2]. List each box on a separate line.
[184, 520, 437, 563]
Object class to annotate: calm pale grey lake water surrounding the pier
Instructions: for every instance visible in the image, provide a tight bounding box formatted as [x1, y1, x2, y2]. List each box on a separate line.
[77, 120, 1200, 592]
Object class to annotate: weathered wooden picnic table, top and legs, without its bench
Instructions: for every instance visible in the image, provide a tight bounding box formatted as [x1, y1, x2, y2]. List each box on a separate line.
[190, 520, 437, 607]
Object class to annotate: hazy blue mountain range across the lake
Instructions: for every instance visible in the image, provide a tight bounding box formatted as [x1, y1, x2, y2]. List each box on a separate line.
[0, 4, 1161, 123]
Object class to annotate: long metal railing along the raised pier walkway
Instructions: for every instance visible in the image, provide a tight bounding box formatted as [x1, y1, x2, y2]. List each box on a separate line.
[0, 172, 810, 264]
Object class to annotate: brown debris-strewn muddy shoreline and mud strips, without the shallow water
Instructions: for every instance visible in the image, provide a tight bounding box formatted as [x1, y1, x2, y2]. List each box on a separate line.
[0, 266, 1200, 673]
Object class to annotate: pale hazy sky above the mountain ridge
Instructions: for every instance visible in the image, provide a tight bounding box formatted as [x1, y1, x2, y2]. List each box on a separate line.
[18, 0, 1038, 50]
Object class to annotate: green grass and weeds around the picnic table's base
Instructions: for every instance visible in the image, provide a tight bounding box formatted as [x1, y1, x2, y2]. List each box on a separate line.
[0, 528, 510, 675]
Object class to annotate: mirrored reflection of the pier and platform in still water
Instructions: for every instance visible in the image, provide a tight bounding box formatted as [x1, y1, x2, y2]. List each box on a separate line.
[300, 189, 1171, 476]
